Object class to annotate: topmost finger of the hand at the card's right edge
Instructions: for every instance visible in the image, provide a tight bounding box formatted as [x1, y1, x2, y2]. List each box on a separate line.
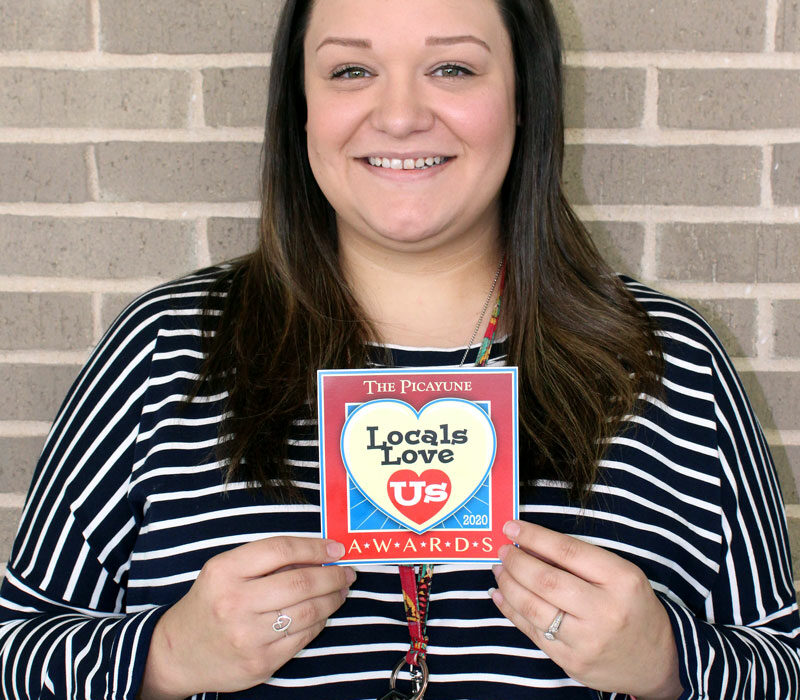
[503, 520, 629, 585]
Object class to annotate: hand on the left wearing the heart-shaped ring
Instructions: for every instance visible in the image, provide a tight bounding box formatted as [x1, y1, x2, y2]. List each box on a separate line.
[140, 537, 355, 700]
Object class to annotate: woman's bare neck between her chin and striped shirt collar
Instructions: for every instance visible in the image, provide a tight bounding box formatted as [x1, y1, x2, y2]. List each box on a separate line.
[340, 237, 502, 348]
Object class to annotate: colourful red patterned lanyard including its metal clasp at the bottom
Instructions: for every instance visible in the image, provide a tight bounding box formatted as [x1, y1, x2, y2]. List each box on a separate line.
[380, 266, 506, 700]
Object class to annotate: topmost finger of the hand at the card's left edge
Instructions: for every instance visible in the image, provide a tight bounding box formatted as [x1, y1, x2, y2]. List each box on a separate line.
[215, 535, 344, 579]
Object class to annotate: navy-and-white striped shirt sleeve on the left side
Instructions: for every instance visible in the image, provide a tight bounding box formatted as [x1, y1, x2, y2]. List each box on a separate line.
[0, 276, 197, 700]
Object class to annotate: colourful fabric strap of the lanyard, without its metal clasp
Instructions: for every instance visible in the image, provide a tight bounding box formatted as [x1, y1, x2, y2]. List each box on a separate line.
[399, 265, 506, 684]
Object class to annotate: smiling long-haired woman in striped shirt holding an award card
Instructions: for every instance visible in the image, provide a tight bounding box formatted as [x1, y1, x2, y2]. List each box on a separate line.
[0, 0, 800, 700]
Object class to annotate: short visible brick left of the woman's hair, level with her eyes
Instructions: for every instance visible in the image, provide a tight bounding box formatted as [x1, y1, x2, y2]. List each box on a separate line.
[203, 68, 269, 127]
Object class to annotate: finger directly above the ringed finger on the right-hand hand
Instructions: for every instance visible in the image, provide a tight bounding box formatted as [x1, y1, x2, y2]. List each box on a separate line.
[498, 545, 600, 618]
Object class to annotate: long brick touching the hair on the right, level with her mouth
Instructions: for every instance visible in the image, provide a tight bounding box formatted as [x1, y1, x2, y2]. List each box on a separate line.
[564, 145, 762, 206]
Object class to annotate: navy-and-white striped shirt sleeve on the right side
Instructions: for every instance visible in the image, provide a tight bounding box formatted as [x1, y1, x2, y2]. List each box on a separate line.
[648, 300, 800, 700]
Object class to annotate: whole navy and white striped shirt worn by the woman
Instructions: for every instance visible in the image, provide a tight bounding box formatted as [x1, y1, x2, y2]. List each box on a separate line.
[0, 268, 800, 700]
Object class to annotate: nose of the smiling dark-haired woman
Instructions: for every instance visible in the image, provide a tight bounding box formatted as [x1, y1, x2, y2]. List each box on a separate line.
[371, 77, 435, 139]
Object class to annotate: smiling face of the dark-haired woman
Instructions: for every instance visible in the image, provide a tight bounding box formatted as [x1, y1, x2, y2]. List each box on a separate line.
[304, 0, 516, 258]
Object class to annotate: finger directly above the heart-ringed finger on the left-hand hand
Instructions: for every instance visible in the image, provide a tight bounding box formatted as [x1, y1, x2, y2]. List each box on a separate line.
[250, 566, 356, 612]
